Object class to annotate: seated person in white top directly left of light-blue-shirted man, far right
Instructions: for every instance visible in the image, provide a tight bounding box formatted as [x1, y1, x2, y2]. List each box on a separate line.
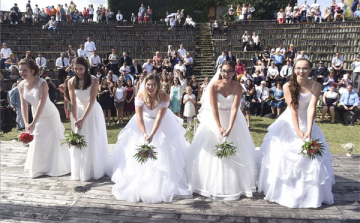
[320, 83, 339, 124]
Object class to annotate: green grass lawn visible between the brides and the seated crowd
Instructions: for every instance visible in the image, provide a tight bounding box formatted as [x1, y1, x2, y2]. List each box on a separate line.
[0, 116, 360, 153]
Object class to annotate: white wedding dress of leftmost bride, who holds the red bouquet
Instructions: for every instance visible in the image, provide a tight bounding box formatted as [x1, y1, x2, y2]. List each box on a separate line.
[19, 79, 70, 178]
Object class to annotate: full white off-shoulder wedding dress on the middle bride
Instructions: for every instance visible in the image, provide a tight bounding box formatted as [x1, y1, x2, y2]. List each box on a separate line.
[107, 98, 192, 203]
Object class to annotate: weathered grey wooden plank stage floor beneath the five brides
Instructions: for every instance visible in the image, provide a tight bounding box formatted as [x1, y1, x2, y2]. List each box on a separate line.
[0, 142, 360, 223]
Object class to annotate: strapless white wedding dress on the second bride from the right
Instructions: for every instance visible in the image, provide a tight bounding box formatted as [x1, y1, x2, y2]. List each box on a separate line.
[186, 93, 258, 200]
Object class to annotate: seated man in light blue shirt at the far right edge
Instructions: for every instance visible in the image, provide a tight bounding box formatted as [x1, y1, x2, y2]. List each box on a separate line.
[339, 84, 360, 125]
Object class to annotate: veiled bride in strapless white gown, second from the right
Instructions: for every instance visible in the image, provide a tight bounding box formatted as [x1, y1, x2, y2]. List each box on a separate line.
[186, 61, 257, 200]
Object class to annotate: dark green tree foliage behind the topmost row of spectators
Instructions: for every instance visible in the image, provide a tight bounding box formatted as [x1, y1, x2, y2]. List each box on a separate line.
[108, 0, 295, 22]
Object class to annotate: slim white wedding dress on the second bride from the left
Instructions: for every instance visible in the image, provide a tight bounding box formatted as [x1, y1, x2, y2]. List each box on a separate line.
[69, 76, 109, 181]
